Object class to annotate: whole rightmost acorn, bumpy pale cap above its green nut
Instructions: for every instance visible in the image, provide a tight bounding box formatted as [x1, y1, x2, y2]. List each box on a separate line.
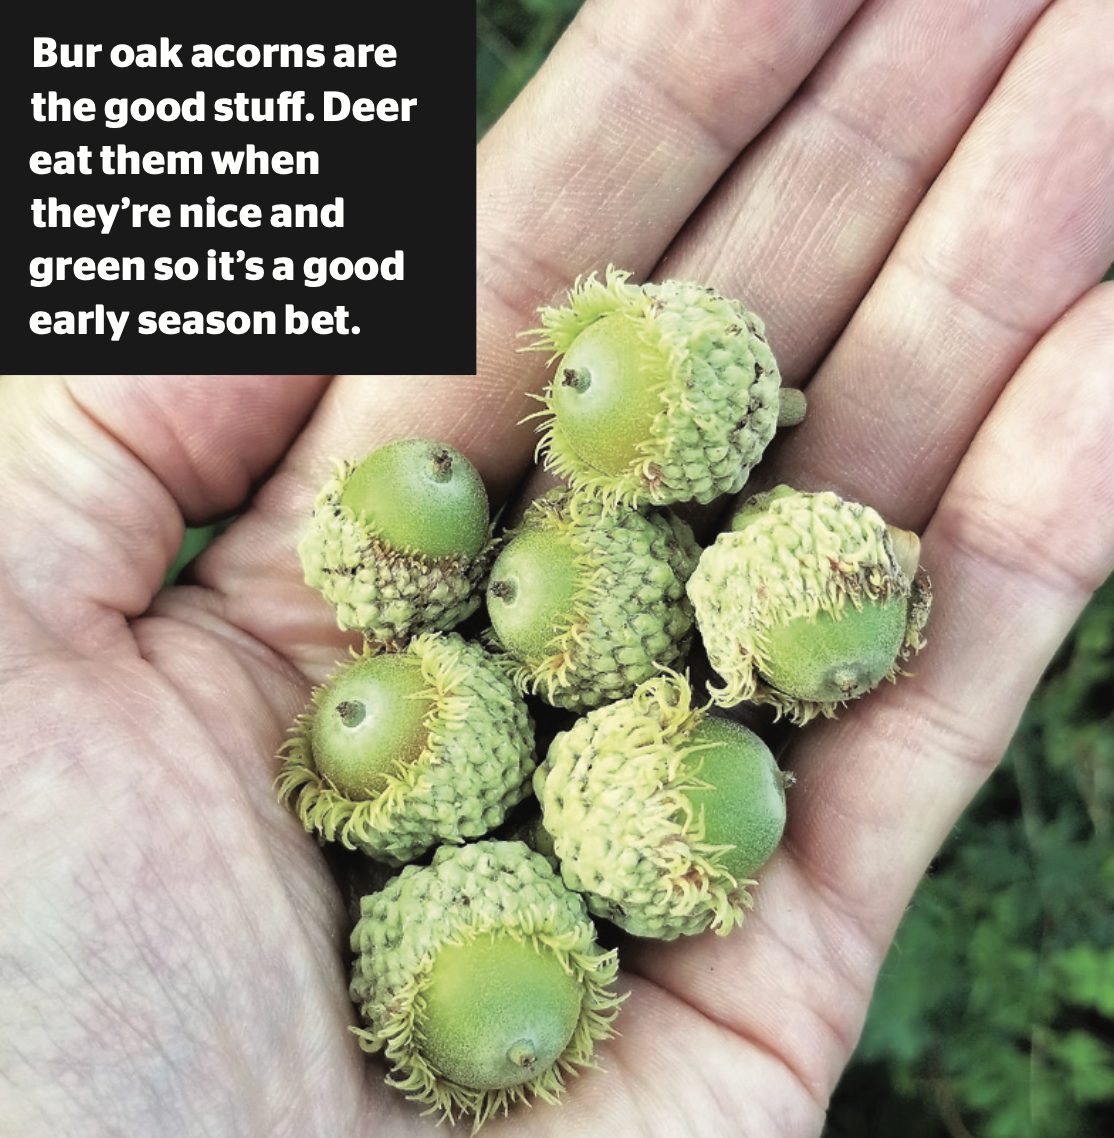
[688, 486, 931, 723]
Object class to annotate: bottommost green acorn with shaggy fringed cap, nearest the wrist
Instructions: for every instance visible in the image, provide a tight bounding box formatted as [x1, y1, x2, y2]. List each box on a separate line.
[350, 841, 621, 1130]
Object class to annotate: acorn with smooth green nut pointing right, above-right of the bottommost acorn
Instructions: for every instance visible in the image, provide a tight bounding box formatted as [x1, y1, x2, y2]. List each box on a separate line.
[534, 675, 787, 940]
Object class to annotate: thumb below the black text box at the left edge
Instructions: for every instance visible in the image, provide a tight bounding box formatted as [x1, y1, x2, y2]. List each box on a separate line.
[0, 376, 323, 648]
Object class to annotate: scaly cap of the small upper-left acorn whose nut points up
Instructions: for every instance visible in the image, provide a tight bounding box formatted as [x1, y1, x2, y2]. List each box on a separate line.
[298, 461, 494, 645]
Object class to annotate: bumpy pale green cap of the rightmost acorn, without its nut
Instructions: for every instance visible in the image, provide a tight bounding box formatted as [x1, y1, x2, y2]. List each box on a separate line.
[688, 486, 931, 724]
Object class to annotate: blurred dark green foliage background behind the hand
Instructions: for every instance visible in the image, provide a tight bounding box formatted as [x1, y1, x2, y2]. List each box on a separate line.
[476, 0, 1114, 1138]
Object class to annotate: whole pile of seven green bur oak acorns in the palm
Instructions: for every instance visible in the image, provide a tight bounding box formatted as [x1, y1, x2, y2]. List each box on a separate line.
[278, 270, 930, 1125]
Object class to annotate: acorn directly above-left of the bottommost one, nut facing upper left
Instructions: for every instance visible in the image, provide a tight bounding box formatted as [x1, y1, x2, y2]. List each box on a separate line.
[277, 633, 535, 865]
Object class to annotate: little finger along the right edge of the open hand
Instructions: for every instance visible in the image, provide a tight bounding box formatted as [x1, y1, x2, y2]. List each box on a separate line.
[793, 279, 1114, 945]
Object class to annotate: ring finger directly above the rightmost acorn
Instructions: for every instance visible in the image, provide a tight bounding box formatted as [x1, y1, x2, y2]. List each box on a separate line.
[764, 0, 1114, 529]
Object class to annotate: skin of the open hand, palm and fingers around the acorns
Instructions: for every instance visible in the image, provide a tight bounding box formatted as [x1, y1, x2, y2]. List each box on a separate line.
[0, 0, 1114, 1138]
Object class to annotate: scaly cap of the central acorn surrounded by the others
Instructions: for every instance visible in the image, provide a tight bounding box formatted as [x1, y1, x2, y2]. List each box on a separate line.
[493, 488, 700, 711]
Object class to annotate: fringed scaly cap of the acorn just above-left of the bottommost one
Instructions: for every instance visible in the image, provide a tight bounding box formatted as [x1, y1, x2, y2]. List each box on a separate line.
[277, 633, 535, 865]
